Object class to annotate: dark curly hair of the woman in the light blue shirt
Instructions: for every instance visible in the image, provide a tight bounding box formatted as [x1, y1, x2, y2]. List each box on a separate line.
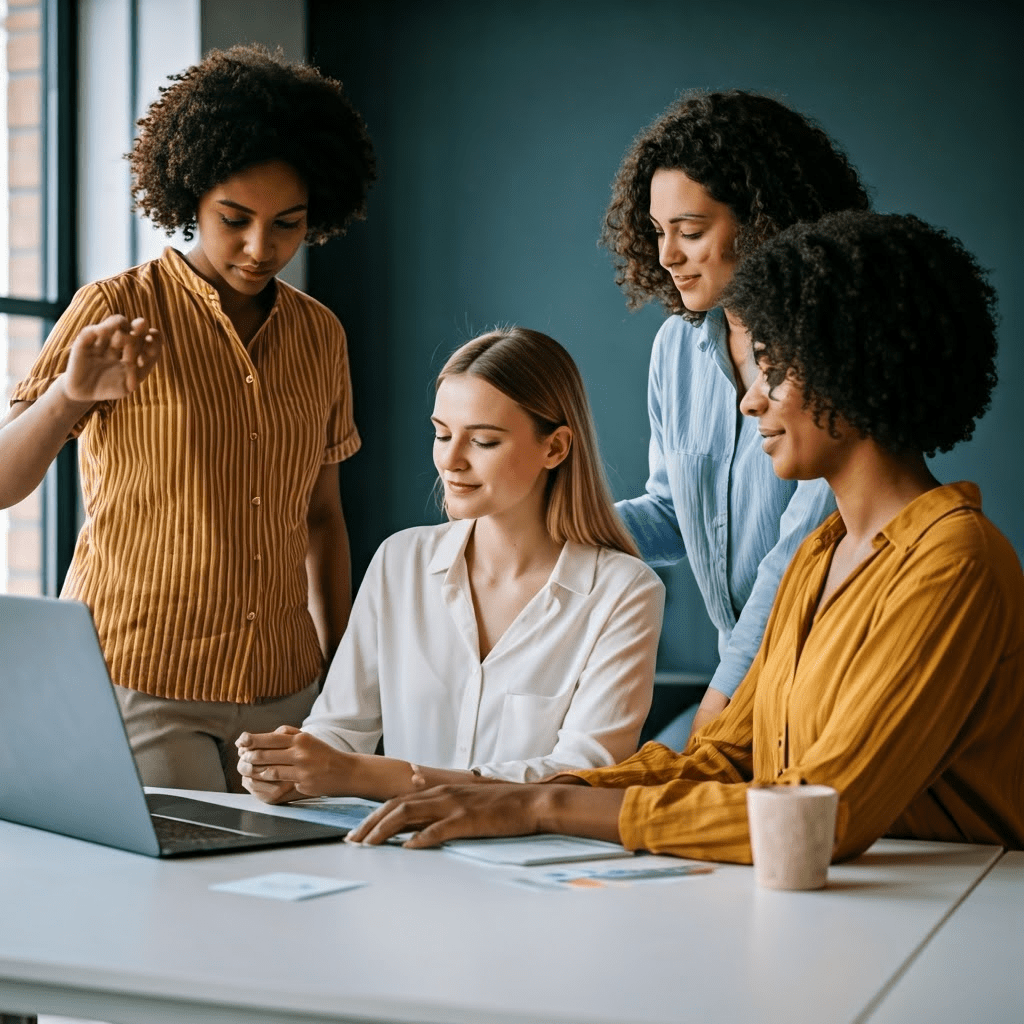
[601, 95, 870, 324]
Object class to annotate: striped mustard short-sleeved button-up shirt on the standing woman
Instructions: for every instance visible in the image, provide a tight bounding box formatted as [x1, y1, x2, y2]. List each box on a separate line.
[12, 249, 359, 703]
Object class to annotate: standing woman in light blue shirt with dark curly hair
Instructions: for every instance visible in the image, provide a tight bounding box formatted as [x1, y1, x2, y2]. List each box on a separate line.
[602, 90, 868, 750]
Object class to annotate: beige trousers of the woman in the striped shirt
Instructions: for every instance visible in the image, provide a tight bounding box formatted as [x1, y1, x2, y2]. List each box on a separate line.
[114, 682, 319, 793]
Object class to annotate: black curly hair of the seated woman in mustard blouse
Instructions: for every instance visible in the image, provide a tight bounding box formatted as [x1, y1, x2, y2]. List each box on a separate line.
[723, 212, 996, 456]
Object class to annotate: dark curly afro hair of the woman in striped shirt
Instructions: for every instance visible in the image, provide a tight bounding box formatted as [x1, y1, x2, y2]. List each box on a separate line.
[128, 45, 376, 244]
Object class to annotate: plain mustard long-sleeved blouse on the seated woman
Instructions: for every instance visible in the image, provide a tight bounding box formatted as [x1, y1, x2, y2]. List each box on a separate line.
[573, 483, 1024, 863]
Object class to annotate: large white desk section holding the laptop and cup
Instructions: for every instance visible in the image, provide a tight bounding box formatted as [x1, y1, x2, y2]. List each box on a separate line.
[0, 797, 999, 1024]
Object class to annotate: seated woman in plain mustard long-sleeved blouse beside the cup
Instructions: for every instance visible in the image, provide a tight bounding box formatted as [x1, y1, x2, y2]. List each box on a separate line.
[351, 213, 1024, 863]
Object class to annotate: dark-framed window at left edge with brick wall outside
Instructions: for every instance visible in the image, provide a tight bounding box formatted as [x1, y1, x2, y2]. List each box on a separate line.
[0, 0, 77, 594]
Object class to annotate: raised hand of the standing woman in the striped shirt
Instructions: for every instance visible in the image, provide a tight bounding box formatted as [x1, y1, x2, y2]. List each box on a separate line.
[63, 313, 163, 403]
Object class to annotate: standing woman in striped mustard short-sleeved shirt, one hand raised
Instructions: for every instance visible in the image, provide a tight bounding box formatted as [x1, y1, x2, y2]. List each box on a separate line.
[0, 46, 375, 790]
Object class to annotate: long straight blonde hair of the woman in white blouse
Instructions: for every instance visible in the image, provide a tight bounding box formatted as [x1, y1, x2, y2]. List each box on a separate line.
[435, 326, 638, 555]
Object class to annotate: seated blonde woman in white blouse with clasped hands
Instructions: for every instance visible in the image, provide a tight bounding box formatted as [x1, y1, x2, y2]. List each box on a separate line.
[238, 328, 664, 803]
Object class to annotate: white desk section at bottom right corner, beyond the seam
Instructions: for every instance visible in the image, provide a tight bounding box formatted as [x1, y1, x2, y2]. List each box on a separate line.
[866, 851, 1024, 1024]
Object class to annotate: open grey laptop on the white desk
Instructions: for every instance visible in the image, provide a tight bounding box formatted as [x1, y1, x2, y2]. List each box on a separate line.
[0, 594, 349, 857]
